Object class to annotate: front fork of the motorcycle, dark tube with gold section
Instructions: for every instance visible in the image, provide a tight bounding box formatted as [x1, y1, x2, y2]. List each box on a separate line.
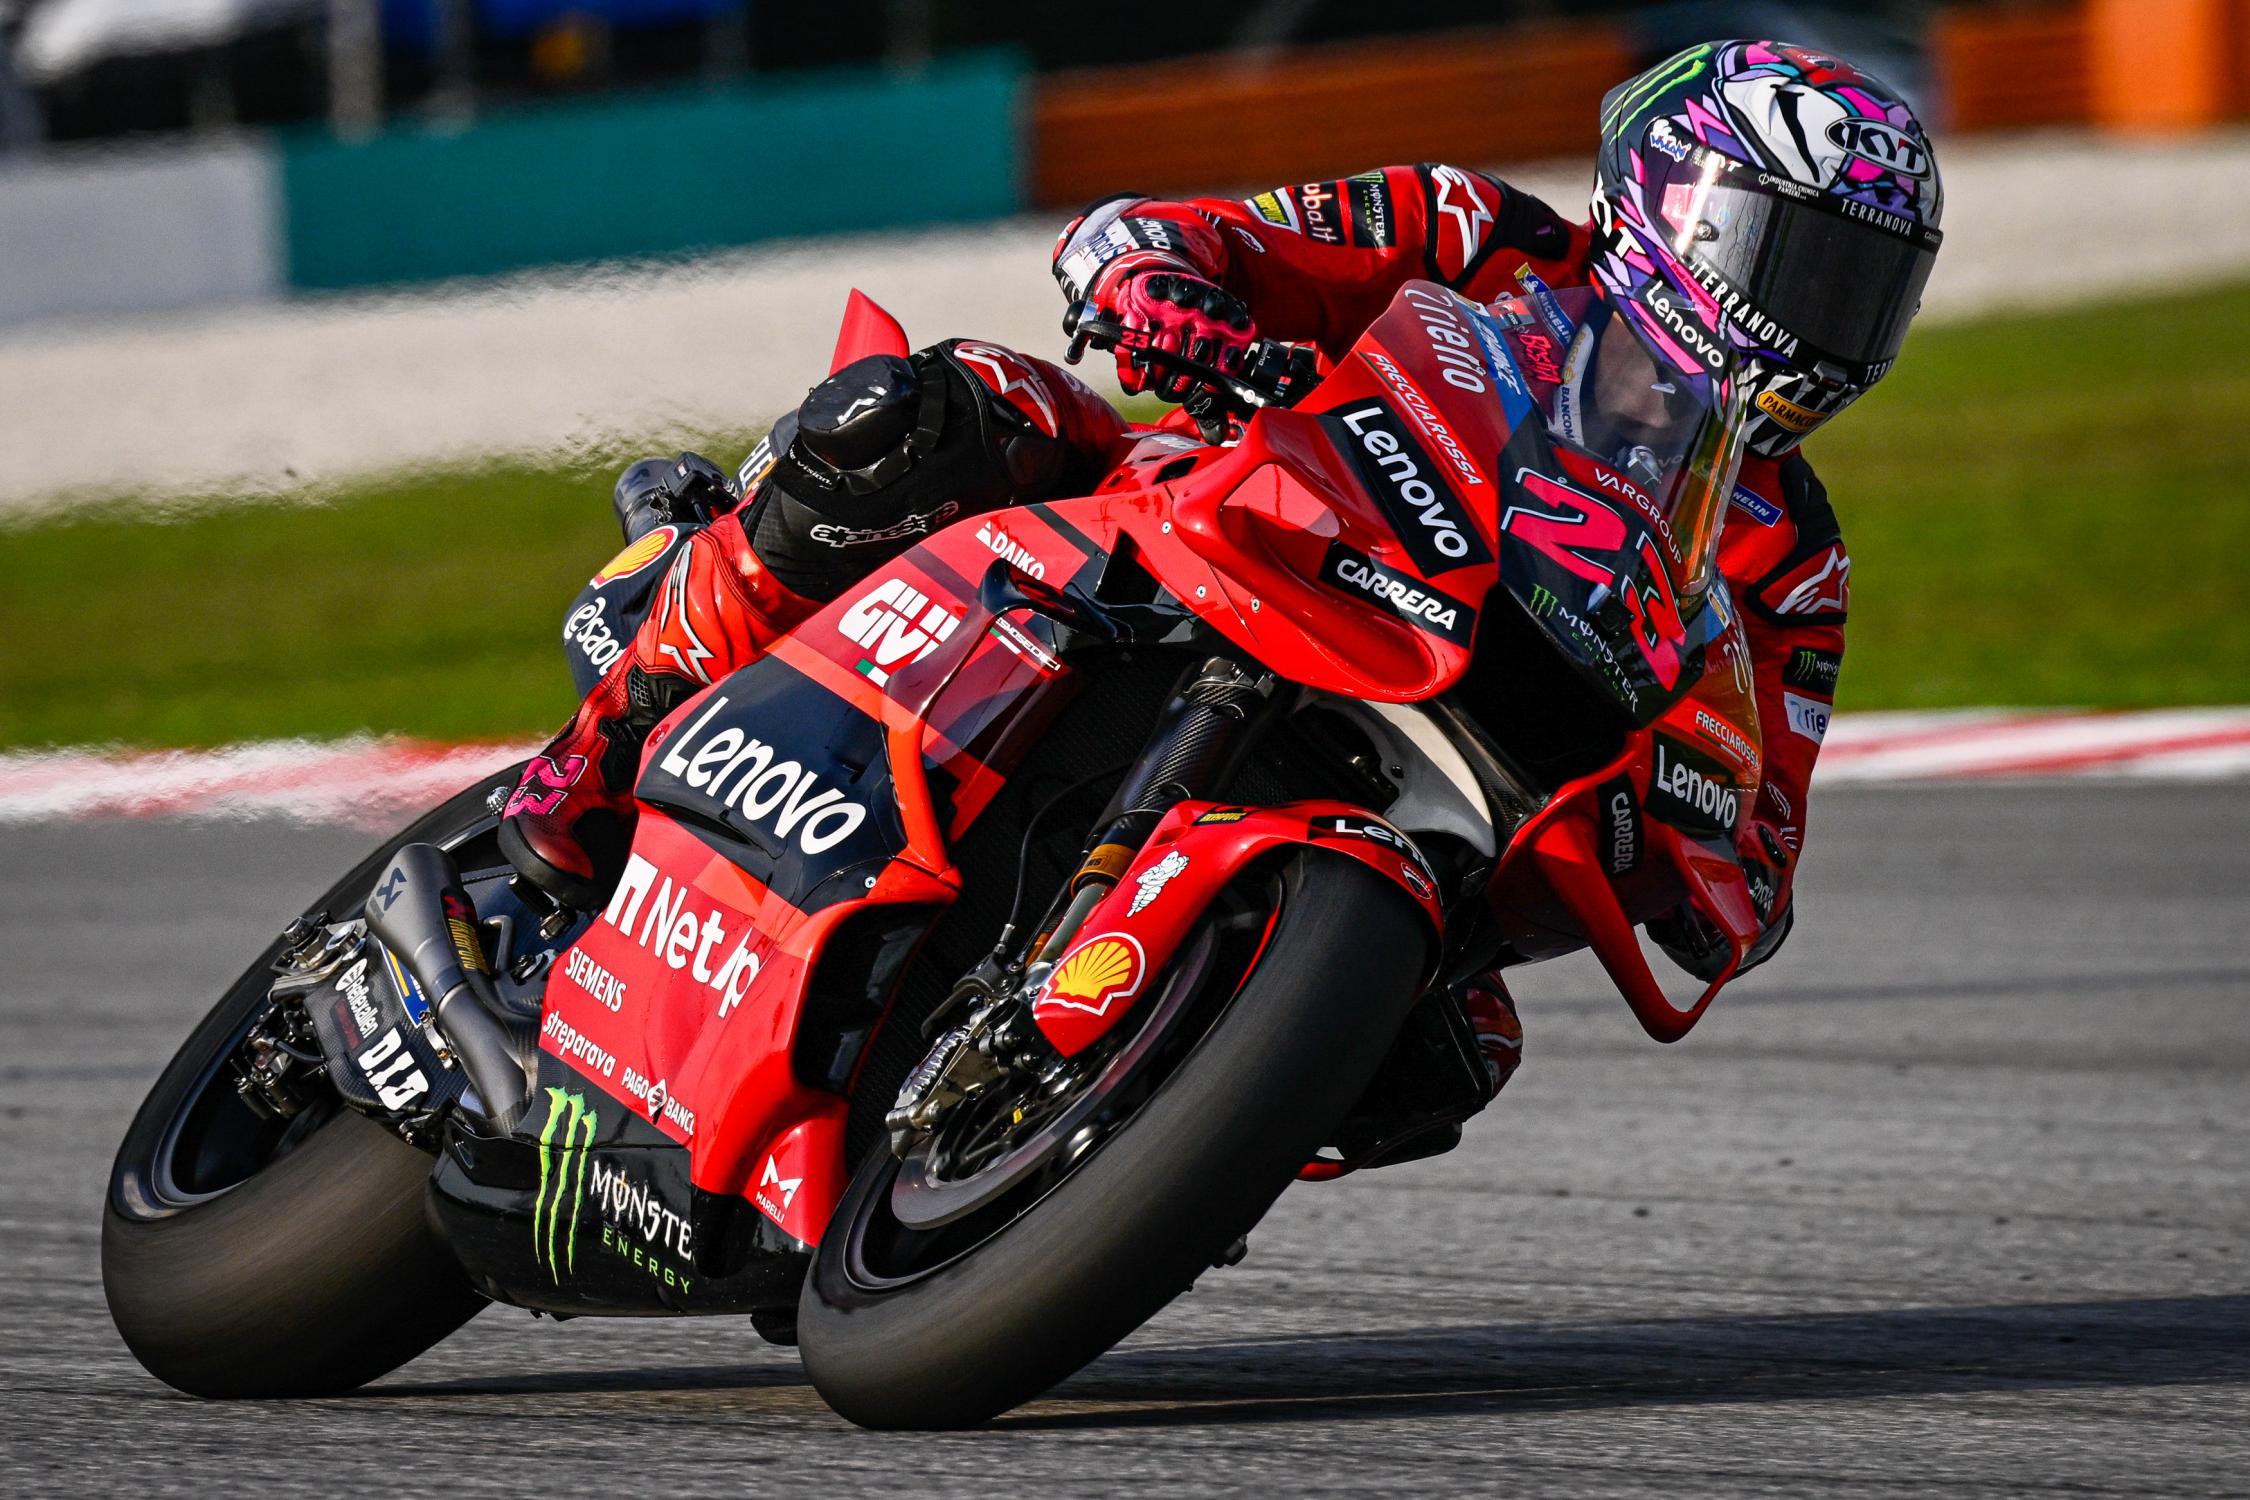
[884, 657, 1280, 1156]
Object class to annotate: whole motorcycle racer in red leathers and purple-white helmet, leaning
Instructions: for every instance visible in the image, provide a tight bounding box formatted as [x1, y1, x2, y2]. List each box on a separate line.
[500, 43, 1940, 1093]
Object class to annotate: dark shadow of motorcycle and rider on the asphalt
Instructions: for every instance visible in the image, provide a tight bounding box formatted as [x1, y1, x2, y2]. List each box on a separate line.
[358, 1295, 2250, 1430]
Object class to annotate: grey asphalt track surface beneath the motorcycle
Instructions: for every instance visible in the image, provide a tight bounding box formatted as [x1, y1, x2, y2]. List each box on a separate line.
[0, 785, 2250, 1500]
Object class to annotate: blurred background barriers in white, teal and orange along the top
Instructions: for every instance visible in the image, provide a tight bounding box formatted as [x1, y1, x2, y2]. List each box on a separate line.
[13, 0, 2250, 324]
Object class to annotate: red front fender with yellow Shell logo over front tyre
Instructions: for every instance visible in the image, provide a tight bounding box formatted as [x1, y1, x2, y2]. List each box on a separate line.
[1031, 801, 1445, 1057]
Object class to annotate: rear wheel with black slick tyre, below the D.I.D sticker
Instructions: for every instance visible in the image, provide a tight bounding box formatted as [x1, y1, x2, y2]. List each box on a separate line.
[101, 774, 513, 1397]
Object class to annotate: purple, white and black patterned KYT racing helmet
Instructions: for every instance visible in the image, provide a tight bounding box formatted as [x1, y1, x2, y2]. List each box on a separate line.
[1593, 40, 1944, 457]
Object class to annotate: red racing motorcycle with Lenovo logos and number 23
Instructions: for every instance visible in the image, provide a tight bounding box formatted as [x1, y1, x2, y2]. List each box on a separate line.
[104, 273, 1760, 1428]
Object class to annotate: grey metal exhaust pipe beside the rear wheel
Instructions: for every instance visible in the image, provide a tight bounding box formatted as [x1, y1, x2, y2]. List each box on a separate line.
[367, 843, 531, 1131]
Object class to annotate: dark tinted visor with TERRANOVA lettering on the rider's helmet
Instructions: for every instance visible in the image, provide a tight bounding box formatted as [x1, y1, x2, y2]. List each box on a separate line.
[1661, 173, 1937, 367]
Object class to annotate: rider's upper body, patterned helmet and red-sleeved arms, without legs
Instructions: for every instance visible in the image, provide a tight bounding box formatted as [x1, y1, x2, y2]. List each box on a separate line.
[1053, 40, 1942, 985]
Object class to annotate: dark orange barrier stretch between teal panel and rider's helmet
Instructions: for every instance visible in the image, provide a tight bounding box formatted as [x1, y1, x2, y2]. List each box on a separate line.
[1028, 25, 1634, 207]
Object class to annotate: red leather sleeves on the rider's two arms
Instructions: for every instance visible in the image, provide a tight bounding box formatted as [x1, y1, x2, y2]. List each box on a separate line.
[1055, 162, 1852, 940]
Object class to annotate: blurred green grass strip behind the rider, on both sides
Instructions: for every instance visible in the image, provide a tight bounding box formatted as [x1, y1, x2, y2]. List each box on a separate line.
[0, 286, 2250, 747]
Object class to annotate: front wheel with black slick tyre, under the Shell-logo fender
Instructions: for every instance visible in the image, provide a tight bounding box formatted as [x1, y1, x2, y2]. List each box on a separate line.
[799, 850, 1431, 1428]
